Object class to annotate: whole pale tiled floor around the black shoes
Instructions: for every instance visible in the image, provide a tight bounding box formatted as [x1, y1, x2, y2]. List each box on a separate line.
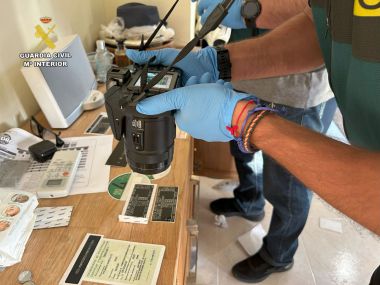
[196, 177, 380, 285]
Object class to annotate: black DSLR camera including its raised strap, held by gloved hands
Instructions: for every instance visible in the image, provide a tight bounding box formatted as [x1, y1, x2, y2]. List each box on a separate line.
[104, 0, 234, 174]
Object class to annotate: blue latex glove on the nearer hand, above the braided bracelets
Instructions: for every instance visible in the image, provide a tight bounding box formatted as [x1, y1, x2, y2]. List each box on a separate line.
[136, 80, 249, 142]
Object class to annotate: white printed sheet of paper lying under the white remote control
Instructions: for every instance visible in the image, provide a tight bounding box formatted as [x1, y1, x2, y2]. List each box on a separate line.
[18, 135, 113, 195]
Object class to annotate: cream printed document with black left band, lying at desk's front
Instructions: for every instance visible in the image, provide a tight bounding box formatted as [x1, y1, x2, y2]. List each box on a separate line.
[59, 233, 165, 285]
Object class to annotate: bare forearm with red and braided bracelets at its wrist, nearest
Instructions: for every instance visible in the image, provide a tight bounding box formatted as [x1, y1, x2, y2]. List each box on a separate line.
[251, 115, 380, 235]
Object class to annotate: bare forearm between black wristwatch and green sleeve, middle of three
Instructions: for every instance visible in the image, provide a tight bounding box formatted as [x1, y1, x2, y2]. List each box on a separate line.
[226, 12, 323, 81]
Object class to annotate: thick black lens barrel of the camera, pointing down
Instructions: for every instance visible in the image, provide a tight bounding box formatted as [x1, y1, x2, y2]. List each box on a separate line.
[124, 106, 176, 174]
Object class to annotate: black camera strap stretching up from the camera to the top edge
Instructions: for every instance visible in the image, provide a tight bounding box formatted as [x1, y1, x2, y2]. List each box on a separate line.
[133, 0, 234, 103]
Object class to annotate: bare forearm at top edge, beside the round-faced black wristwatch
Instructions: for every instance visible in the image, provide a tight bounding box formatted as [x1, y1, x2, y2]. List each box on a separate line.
[256, 0, 307, 29]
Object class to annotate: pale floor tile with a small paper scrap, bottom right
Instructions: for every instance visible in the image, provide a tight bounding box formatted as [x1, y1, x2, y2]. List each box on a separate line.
[302, 197, 380, 285]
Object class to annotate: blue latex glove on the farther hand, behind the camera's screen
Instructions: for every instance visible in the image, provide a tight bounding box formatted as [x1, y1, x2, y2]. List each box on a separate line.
[127, 47, 219, 85]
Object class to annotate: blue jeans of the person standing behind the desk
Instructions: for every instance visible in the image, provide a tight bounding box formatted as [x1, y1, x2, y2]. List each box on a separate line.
[230, 98, 336, 266]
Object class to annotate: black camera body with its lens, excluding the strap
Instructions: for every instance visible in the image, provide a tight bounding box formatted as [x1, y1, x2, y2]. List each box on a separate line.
[104, 66, 181, 174]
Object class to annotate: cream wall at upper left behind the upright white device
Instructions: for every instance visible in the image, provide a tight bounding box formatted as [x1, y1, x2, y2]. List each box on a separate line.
[0, 0, 105, 131]
